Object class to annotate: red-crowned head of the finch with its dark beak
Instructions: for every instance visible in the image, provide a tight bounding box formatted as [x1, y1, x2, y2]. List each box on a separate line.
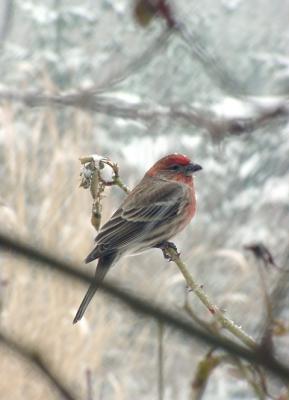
[147, 153, 202, 182]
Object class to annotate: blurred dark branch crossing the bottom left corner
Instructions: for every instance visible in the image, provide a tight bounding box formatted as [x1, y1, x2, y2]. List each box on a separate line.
[0, 332, 76, 400]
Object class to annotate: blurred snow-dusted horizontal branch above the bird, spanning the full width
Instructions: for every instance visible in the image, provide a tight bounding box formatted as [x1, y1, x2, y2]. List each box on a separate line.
[0, 89, 289, 140]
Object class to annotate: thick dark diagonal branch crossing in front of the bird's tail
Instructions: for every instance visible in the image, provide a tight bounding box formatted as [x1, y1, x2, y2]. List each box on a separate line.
[0, 233, 289, 381]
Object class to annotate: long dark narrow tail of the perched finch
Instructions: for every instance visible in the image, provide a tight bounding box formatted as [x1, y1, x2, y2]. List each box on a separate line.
[73, 253, 115, 324]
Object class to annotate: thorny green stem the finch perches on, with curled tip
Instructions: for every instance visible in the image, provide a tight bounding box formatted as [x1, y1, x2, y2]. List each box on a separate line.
[81, 156, 257, 350]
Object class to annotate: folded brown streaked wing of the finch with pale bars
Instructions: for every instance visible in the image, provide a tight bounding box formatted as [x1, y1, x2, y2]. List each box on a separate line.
[86, 181, 187, 258]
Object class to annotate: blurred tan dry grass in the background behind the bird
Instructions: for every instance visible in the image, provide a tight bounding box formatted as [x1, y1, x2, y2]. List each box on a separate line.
[0, 101, 274, 400]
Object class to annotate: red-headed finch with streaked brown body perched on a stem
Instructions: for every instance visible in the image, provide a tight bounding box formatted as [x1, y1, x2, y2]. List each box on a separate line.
[73, 153, 202, 324]
